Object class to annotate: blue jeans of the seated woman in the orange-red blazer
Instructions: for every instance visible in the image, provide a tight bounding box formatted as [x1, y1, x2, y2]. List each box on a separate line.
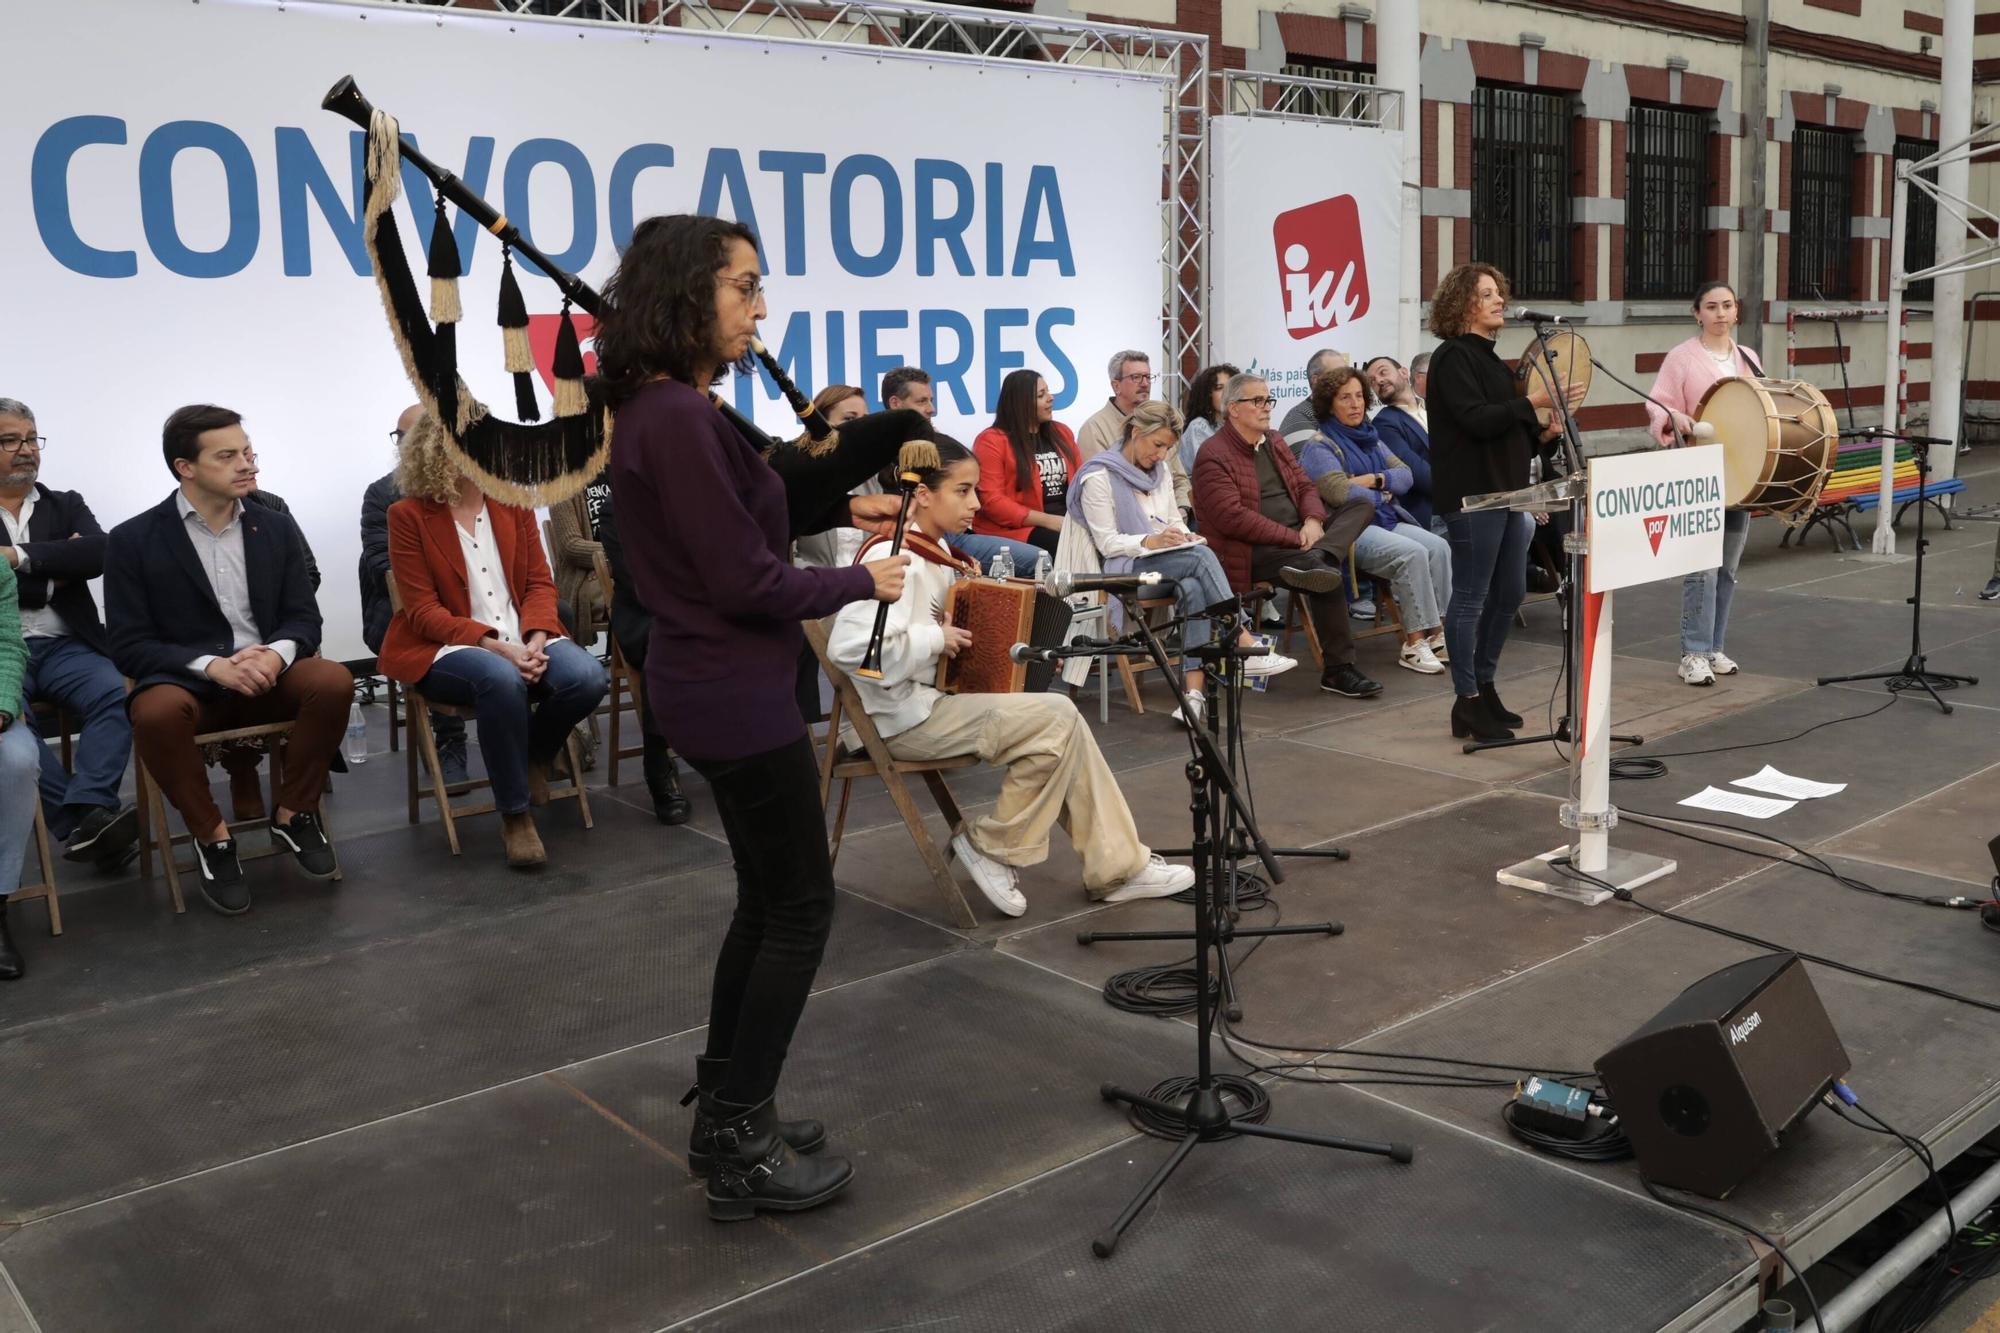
[416, 638, 608, 815]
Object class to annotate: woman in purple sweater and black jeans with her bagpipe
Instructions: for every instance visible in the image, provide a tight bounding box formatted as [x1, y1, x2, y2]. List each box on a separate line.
[326, 80, 930, 1221]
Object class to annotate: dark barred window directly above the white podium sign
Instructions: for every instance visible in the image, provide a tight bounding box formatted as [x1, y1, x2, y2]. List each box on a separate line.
[1626, 106, 1708, 300]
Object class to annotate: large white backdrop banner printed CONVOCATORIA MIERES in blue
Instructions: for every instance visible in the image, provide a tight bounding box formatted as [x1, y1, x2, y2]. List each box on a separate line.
[0, 0, 1162, 656]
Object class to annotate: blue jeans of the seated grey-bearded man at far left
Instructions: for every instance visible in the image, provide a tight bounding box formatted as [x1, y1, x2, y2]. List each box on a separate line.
[20, 636, 132, 839]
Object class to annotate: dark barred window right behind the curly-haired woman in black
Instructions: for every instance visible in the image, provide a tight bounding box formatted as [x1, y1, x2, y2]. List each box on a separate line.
[1472, 84, 1574, 300]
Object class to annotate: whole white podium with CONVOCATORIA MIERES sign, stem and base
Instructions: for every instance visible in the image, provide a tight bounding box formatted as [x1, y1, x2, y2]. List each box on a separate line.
[1466, 444, 1724, 907]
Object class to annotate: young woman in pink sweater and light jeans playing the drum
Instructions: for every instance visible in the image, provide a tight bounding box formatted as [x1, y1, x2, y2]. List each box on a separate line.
[1646, 282, 1764, 685]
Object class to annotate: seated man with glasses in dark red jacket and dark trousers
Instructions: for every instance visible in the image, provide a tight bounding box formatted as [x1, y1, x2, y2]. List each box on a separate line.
[1194, 374, 1382, 699]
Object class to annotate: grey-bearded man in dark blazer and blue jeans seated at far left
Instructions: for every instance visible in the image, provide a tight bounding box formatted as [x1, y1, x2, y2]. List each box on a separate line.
[0, 398, 138, 869]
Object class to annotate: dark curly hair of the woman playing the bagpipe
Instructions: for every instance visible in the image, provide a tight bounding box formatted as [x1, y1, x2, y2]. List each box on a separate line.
[596, 212, 756, 408]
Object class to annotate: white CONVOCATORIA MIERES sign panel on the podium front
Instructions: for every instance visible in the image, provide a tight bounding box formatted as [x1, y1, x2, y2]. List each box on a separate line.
[1590, 444, 1722, 592]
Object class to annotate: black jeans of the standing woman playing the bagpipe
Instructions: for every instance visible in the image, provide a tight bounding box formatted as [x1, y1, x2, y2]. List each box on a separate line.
[688, 737, 834, 1107]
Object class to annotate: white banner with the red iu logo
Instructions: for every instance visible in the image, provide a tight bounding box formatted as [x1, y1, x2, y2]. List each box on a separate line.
[1208, 116, 1416, 422]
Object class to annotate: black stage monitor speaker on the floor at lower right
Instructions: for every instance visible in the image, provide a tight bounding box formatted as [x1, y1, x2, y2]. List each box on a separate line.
[1598, 953, 1852, 1199]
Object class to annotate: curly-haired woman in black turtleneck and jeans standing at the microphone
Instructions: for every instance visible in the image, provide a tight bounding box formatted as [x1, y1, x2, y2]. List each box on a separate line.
[1430, 264, 1584, 741]
